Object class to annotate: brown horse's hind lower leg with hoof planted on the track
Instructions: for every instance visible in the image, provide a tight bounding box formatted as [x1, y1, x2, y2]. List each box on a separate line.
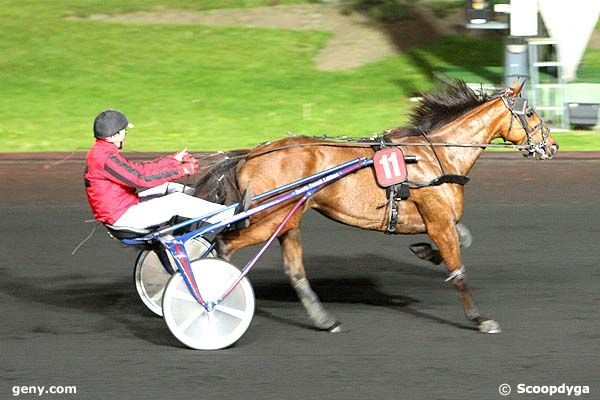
[279, 228, 341, 332]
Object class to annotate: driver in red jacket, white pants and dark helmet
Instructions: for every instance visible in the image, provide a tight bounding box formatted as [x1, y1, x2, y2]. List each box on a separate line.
[84, 109, 250, 229]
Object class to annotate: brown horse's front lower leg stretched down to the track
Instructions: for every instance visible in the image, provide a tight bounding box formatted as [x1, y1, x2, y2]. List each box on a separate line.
[427, 217, 501, 333]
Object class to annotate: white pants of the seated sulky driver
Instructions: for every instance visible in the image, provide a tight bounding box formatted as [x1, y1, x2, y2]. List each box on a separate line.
[113, 183, 235, 229]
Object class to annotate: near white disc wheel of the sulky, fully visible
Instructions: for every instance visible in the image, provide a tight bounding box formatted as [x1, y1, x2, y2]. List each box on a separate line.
[163, 258, 254, 350]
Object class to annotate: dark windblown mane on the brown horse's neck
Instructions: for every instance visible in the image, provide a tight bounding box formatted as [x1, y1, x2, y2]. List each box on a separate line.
[388, 79, 495, 138]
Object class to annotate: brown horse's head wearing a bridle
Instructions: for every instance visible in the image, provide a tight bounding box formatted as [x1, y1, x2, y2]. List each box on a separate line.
[500, 82, 558, 160]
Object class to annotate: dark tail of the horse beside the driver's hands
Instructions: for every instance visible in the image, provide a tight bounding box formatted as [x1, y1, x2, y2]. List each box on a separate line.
[196, 149, 250, 204]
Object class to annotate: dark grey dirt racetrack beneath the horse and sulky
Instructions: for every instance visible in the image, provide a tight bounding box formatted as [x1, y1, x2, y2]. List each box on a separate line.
[0, 154, 600, 400]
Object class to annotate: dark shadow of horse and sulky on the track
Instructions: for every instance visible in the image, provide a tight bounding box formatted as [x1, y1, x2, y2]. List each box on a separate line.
[0, 255, 473, 346]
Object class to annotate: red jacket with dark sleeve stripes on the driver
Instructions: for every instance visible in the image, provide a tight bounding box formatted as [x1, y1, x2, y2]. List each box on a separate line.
[84, 139, 186, 224]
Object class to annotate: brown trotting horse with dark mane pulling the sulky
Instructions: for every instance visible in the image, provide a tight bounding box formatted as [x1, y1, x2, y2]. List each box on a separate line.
[198, 81, 558, 333]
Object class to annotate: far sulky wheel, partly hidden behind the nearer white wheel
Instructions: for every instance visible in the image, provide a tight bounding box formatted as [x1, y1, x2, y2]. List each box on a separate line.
[133, 237, 216, 316]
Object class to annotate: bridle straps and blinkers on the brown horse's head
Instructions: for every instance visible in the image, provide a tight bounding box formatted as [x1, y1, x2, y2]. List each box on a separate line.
[502, 89, 551, 160]
